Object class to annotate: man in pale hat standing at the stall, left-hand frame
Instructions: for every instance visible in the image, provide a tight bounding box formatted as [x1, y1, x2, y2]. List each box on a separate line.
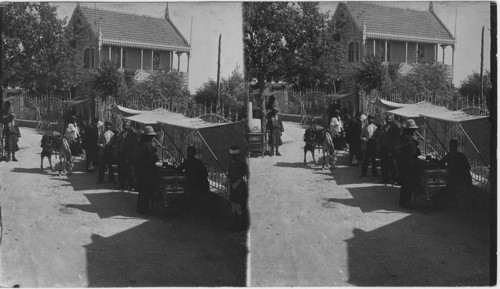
[134, 125, 158, 215]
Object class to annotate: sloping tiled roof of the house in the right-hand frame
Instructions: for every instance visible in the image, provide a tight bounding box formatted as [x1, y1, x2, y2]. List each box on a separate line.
[344, 2, 454, 42]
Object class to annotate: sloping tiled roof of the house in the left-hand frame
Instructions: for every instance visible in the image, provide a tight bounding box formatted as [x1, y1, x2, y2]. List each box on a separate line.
[77, 6, 189, 51]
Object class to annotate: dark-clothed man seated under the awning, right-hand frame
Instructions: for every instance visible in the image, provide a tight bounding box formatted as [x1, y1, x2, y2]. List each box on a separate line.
[441, 139, 472, 204]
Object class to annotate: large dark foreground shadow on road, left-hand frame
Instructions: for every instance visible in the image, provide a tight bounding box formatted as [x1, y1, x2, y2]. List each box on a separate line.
[85, 219, 247, 287]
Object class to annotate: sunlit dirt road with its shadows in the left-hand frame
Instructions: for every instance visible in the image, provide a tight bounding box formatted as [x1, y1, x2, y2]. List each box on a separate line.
[0, 128, 247, 287]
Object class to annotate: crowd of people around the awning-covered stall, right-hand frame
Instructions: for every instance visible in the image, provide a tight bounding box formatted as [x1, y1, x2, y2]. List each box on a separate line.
[312, 104, 472, 208]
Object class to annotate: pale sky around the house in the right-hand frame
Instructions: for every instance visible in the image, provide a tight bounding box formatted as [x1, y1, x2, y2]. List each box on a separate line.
[320, 1, 491, 86]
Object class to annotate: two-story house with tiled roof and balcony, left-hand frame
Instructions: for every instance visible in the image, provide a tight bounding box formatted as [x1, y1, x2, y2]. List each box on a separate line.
[68, 4, 191, 85]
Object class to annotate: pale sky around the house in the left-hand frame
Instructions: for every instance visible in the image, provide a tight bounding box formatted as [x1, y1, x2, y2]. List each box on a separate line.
[51, 2, 243, 93]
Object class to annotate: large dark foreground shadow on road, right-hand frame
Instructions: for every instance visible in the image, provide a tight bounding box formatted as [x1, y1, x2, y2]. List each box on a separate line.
[346, 209, 490, 287]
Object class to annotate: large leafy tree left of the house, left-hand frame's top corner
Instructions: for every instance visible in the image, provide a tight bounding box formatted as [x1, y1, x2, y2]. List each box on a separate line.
[3, 2, 83, 93]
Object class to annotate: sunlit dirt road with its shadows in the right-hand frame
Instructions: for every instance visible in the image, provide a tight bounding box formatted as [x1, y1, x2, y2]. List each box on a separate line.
[250, 122, 490, 286]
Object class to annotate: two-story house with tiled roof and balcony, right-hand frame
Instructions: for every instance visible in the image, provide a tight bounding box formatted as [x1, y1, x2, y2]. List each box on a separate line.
[333, 1, 456, 112]
